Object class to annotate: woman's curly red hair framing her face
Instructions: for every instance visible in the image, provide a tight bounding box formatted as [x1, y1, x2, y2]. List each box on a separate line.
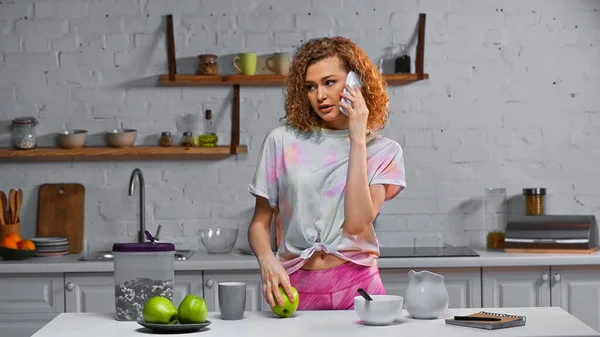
[282, 36, 389, 132]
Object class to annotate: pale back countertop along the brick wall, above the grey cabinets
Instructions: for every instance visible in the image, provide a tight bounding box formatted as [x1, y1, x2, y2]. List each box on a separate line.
[0, 250, 600, 274]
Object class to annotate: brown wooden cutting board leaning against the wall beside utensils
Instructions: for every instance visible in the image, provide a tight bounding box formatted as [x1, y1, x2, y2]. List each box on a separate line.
[37, 184, 85, 254]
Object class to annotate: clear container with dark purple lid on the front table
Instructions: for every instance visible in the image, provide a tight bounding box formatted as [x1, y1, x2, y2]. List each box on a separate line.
[112, 241, 175, 321]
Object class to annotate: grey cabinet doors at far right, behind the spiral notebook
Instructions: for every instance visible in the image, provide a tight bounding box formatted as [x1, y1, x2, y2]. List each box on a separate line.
[482, 266, 600, 331]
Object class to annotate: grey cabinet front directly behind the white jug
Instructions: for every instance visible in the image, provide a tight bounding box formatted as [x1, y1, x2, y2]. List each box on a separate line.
[379, 268, 481, 308]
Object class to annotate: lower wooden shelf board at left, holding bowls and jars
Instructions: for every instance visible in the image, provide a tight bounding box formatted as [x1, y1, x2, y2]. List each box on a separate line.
[0, 145, 248, 161]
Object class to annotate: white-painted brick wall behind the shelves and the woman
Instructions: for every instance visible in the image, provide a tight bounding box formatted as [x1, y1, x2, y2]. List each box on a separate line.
[0, 0, 600, 250]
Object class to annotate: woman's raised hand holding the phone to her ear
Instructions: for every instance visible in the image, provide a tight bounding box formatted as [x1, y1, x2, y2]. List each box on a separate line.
[339, 84, 369, 142]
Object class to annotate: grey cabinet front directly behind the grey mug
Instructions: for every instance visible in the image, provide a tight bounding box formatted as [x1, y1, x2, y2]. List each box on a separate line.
[204, 270, 271, 311]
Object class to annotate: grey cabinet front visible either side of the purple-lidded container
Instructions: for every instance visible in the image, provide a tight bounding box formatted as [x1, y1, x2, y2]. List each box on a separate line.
[65, 272, 202, 313]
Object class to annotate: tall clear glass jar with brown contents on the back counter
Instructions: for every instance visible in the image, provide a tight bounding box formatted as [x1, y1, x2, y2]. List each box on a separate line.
[485, 188, 507, 249]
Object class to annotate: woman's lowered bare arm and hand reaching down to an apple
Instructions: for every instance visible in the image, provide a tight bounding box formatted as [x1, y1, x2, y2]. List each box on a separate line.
[248, 196, 294, 307]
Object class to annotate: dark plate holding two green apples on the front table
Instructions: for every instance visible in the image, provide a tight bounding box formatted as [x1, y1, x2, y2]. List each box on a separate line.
[137, 294, 211, 334]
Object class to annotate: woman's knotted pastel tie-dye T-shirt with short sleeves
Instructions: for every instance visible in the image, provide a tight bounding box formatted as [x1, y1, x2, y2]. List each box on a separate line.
[248, 126, 406, 274]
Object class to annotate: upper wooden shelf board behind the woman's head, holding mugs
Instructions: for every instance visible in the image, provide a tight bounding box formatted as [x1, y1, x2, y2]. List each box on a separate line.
[159, 74, 429, 87]
